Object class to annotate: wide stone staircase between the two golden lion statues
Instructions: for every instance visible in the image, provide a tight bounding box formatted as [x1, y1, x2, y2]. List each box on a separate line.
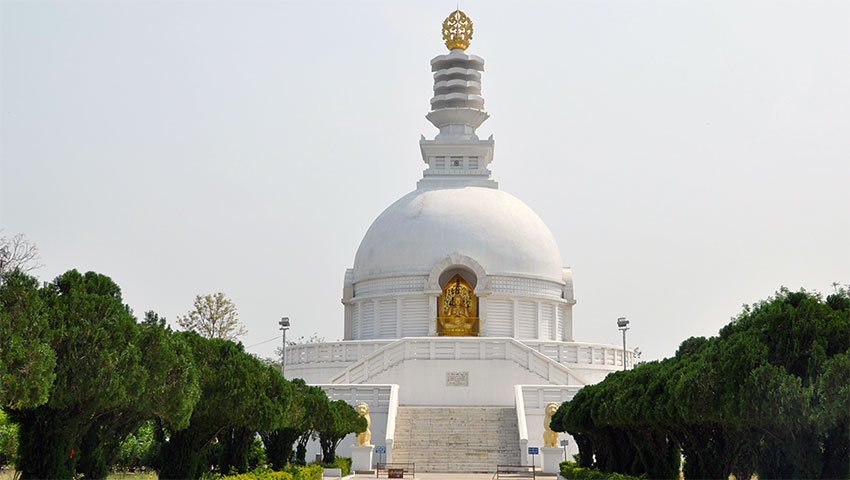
[393, 406, 520, 473]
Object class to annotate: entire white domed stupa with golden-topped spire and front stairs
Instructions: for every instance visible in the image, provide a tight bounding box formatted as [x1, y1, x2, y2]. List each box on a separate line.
[292, 11, 632, 471]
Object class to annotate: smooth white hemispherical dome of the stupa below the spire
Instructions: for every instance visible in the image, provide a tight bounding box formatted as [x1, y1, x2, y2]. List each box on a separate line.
[353, 186, 562, 282]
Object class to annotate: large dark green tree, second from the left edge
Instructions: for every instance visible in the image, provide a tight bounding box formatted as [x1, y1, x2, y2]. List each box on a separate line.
[3, 270, 142, 478]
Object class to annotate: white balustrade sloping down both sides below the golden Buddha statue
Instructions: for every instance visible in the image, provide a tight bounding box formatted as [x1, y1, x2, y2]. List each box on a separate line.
[331, 337, 587, 385]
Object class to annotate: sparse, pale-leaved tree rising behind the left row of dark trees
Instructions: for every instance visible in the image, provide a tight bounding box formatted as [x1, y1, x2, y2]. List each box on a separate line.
[177, 292, 247, 341]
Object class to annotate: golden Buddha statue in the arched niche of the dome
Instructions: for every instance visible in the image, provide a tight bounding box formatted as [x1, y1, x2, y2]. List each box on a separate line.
[437, 274, 479, 337]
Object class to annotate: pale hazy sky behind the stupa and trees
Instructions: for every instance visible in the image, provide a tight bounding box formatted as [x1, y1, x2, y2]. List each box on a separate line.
[0, 0, 850, 359]
